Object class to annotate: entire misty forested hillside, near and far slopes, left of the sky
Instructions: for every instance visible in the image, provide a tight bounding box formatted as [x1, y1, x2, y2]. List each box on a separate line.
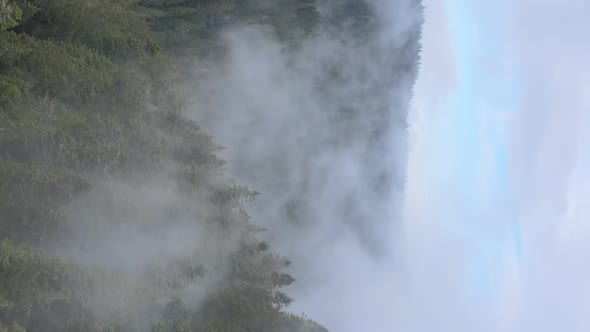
[0, 0, 430, 332]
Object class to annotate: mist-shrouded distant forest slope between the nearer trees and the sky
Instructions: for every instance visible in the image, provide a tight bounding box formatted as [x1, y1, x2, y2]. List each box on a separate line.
[187, 0, 422, 331]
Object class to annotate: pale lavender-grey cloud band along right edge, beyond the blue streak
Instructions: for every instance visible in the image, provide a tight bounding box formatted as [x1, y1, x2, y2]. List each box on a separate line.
[506, 0, 590, 332]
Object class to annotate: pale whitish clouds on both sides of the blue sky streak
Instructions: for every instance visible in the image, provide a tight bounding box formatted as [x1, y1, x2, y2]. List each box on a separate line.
[410, 0, 590, 332]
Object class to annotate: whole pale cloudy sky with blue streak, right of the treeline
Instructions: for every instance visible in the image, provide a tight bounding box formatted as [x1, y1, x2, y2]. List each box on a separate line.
[400, 0, 590, 332]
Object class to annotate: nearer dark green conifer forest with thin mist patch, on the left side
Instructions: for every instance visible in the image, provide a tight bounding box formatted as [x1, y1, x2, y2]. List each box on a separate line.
[0, 0, 426, 332]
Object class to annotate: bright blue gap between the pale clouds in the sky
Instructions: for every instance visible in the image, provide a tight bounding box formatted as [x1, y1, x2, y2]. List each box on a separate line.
[429, 0, 524, 296]
